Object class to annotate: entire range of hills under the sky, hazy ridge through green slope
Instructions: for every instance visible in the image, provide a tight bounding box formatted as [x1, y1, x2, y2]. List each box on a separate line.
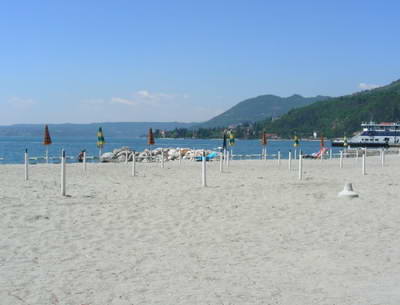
[7, 80, 400, 137]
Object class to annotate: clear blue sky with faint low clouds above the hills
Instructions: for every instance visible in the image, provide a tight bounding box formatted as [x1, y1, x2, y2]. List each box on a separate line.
[0, 0, 400, 125]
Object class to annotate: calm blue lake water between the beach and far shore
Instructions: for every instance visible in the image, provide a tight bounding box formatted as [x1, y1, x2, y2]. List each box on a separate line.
[0, 137, 338, 164]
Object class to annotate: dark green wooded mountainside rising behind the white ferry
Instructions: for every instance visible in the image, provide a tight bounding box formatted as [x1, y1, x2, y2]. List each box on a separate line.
[257, 80, 400, 137]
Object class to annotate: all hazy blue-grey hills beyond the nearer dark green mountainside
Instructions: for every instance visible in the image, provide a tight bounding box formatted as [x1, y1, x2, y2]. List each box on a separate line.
[0, 94, 329, 137]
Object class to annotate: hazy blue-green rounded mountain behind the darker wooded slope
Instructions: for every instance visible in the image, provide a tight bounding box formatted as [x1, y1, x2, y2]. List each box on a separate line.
[197, 94, 329, 128]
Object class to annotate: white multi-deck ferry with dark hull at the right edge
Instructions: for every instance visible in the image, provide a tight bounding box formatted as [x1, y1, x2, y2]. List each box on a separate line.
[332, 122, 400, 147]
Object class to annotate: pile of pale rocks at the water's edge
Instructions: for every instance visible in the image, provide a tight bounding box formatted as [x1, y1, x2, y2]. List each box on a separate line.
[100, 147, 219, 162]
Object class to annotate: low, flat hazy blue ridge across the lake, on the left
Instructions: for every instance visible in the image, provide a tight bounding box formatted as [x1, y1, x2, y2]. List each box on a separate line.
[0, 122, 193, 138]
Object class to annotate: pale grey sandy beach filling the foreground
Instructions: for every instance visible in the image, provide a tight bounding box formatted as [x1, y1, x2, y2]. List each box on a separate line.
[0, 155, 400, 305]
